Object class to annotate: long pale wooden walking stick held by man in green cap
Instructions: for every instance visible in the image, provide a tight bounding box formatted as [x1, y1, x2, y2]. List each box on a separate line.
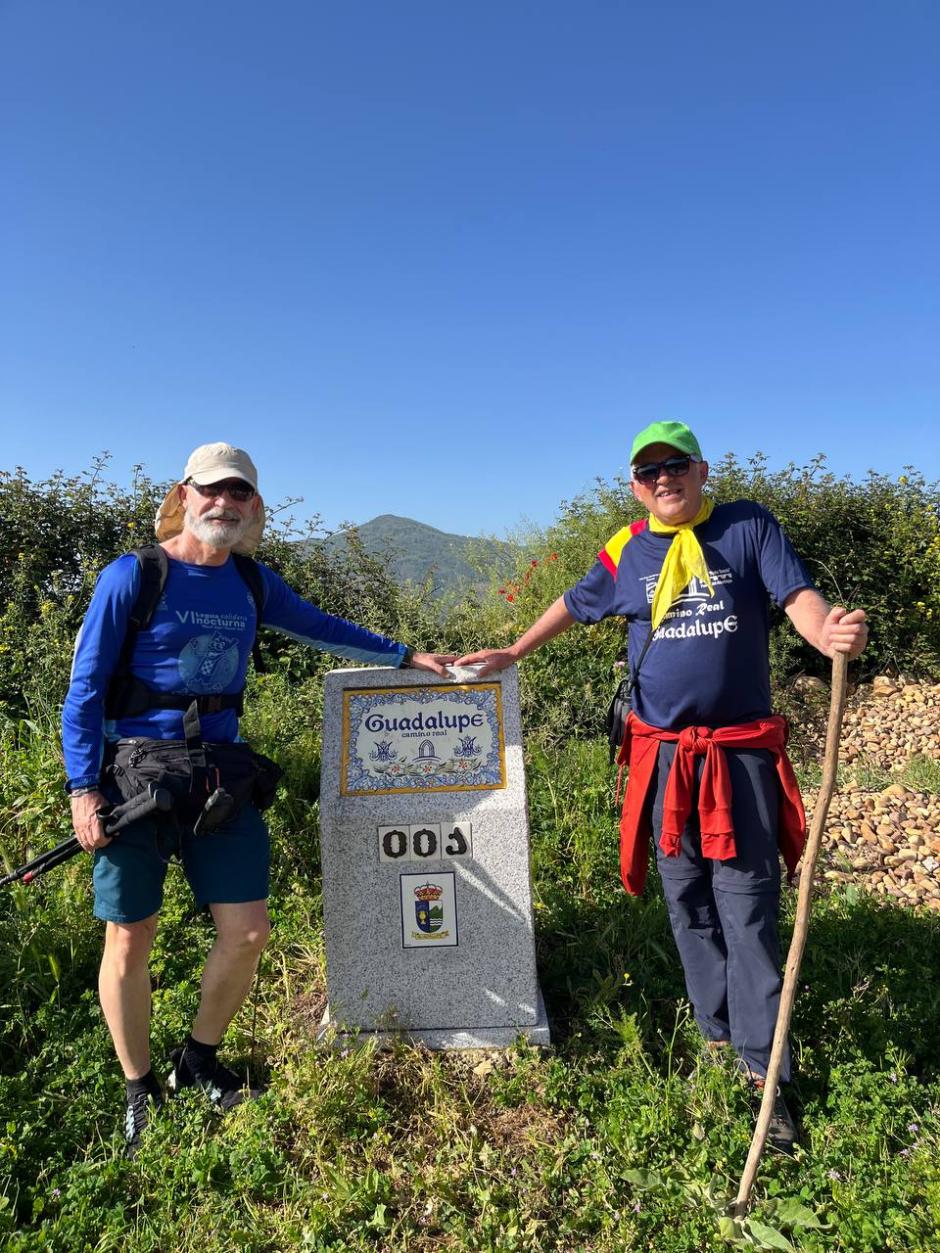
[733, 653, 847, 1218]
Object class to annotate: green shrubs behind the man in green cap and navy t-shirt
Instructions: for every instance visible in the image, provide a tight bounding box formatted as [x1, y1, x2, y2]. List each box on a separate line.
[481, 455, 940, 738]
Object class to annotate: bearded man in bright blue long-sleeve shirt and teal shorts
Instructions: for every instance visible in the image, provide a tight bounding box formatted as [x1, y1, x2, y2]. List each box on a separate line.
[63, 444, 452, 1153]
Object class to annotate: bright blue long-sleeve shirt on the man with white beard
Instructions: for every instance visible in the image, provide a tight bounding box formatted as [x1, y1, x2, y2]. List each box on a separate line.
[63, 553, 405, 791]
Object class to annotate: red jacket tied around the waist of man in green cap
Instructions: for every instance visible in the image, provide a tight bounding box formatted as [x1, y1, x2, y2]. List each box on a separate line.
[617, 712, 806, 896]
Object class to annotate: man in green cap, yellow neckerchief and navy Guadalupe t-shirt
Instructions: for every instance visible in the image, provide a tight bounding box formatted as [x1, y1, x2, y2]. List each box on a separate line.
[457, 422, 867, 1148]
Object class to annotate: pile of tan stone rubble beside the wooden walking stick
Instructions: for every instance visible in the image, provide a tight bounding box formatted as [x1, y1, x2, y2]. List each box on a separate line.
[803, 678, 940, 912]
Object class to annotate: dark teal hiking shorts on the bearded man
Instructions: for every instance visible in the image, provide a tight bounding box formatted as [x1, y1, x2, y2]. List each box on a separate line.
[93, 804, 271, 922]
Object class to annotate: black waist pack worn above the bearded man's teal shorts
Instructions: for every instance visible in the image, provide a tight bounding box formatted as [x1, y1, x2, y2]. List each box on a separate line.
[105, 739, 282, 834]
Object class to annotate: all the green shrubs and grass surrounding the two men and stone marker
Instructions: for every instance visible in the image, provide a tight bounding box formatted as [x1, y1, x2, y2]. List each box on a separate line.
[0, 459, 940, 1253]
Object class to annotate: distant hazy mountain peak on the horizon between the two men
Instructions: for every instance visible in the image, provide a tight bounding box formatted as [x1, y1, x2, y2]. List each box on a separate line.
[305, 514, 513, 596]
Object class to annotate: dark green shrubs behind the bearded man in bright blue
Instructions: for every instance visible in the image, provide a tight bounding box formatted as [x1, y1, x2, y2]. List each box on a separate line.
[0, 459, 481, 715]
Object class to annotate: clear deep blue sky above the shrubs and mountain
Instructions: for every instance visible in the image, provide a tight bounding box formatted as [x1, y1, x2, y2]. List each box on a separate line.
[0, 0, 940, 534]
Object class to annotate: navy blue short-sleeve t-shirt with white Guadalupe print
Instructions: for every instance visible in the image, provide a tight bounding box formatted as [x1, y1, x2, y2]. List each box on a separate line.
[564, 500, 812, 730]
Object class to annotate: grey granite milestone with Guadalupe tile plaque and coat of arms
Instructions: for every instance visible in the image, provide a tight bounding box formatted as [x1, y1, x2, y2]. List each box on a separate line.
[320, 668, 549, 1049]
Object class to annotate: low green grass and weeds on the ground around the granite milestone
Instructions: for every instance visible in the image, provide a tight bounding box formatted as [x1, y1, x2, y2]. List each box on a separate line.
[0, 702, 940, 1253]
